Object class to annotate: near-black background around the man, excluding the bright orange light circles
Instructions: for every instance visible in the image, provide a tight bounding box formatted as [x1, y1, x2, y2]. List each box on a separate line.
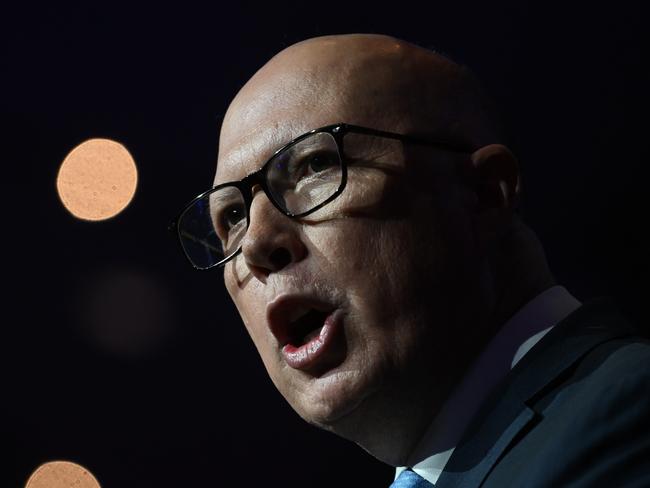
[0, 0, 650, 488]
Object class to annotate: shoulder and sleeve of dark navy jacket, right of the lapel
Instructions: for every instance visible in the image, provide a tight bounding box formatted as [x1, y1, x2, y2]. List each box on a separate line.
[498, 337, 650, 487]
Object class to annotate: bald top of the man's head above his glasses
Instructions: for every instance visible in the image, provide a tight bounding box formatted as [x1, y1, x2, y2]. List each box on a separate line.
[221, 34, 500, 171]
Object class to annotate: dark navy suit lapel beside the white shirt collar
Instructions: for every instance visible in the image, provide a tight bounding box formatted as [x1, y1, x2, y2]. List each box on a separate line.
[436, 299, 634, 488]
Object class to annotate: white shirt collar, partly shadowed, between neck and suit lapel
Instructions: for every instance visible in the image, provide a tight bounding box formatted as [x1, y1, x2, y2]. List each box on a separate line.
[395, 286, 581, 484]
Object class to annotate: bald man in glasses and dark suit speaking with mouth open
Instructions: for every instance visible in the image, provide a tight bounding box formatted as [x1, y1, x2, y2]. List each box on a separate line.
[171, 35, 650, 486]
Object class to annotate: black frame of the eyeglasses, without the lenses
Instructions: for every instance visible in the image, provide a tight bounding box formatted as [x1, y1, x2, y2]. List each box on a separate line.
[168, 123, 473, 271]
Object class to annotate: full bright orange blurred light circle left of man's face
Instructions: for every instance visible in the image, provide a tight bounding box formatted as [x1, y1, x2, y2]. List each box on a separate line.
[56, 139, 138, 221]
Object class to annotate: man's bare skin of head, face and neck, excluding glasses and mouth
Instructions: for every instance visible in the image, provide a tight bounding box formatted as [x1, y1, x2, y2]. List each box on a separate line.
[215, 35, 552, 465]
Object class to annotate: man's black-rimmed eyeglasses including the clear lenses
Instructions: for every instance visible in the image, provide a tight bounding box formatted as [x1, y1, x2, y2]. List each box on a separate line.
[169, 123, 471, 270]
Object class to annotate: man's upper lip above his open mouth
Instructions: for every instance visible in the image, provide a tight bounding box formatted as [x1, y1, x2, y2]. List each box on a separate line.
[266, 294, 336, 348]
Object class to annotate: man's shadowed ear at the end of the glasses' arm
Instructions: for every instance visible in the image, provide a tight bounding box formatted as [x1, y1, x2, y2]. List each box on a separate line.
[472, 144, 520, 210]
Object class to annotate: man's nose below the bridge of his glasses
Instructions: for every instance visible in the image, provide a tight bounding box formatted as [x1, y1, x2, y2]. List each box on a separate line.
[241, 192, 307, 283]
